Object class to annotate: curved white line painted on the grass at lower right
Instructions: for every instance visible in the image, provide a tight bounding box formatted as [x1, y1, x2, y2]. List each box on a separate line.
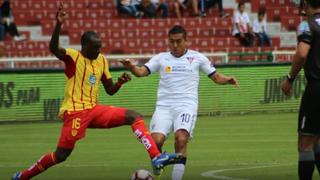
[201, 164, 293, 180]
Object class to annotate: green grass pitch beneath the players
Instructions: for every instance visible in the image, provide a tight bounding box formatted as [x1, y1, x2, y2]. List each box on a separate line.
[0, 113, 319, 180]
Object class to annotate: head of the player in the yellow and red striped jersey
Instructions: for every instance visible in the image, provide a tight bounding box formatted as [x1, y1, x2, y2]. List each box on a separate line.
[81, 31, 102, 60]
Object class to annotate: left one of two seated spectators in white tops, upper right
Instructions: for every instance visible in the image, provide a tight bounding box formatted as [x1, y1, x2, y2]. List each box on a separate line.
[232, 2, 254, 47]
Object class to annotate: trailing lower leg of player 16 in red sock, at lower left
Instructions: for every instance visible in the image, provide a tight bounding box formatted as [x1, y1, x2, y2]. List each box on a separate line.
[12, 148, 72, 180]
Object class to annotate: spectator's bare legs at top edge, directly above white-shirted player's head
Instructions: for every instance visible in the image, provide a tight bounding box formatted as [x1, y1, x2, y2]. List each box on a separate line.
[173, 0, 200, 18]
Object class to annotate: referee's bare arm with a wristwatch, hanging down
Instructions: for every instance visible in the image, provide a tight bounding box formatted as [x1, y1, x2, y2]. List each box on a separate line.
[281, 41, 310, 96]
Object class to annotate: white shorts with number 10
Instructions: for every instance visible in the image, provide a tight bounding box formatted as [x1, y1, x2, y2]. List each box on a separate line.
[150, 106, 198, 138]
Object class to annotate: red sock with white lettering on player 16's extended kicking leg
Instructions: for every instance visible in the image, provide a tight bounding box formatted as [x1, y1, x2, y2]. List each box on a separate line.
[131, 118, 160, 158]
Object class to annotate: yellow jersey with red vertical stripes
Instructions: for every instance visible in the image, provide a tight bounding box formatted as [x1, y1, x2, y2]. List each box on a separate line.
[59, 49, 111, 117]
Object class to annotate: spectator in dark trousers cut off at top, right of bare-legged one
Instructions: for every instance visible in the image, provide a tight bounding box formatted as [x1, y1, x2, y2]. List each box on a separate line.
[199, 0, 229, 18]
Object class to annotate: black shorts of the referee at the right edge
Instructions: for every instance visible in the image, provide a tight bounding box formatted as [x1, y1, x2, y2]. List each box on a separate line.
[298, 83, 320, 135]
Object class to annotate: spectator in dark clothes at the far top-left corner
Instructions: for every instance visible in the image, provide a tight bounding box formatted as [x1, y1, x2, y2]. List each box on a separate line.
[0, 0, 26, 41]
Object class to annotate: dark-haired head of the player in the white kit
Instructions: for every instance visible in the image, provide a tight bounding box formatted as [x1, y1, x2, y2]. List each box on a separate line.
[169, 25, 187, 57]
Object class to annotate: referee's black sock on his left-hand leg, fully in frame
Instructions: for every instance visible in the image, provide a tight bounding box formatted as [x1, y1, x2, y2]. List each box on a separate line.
[298, 151, 314, 180]
